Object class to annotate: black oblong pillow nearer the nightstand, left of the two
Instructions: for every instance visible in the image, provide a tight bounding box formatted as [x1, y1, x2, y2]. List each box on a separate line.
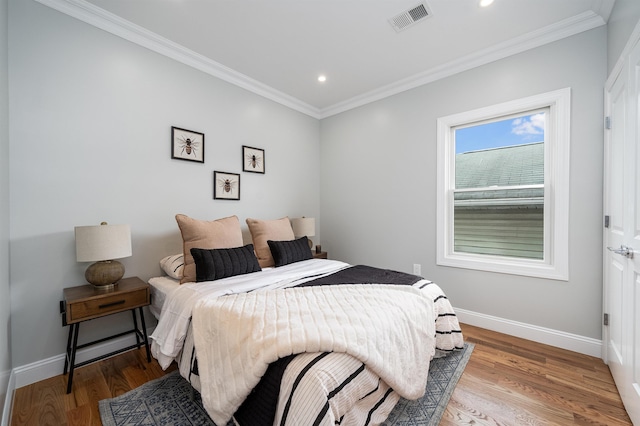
[191, 244, 262, 283]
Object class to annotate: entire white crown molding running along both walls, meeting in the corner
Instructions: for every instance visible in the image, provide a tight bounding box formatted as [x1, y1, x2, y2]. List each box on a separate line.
[35, 0, 610, 119]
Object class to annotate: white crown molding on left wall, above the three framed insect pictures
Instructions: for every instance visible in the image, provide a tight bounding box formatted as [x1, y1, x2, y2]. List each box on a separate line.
[35, 0, 320, 118]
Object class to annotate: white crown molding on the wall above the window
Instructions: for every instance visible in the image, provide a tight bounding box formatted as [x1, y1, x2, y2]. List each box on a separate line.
[320, 11, 606, 119]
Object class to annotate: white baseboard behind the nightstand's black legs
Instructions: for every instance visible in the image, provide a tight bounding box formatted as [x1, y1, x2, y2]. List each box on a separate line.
[13, 326, 155, 389]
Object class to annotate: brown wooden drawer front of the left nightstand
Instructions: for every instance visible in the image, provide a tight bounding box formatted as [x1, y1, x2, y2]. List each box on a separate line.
[67, 289, 149, 323]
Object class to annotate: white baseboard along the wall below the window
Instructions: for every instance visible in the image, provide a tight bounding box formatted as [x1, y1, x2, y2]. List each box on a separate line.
[454, 308, 602, 358]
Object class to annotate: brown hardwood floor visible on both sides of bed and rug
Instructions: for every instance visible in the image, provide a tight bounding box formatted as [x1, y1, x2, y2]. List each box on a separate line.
[11, 324, 631, 426]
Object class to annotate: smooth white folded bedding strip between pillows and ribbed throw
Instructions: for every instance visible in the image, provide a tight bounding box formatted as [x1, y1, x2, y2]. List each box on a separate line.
[149, 259, 349, 369]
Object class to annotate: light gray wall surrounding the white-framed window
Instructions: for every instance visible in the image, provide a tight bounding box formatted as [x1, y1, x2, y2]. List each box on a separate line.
[320, 27, 607, 339]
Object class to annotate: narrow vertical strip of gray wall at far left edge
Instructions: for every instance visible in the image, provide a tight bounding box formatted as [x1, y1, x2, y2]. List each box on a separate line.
[0, 0, 11, 418]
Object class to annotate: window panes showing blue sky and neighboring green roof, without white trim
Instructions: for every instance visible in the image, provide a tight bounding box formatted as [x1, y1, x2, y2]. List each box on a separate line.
[452, 108, 549, 259]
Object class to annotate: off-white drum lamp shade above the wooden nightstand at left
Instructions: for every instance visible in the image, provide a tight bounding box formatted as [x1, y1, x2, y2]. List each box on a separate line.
[75, 224, 131, 262]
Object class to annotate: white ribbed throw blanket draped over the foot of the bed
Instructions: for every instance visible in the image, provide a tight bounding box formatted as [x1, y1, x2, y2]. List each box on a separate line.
[193, 284, 436, 424]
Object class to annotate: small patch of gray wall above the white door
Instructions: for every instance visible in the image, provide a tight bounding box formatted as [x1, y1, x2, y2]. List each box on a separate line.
[607, 0, 640, 72]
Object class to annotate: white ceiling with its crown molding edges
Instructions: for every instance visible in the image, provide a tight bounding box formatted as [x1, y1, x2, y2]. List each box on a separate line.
[38, 0, 614, 118]
